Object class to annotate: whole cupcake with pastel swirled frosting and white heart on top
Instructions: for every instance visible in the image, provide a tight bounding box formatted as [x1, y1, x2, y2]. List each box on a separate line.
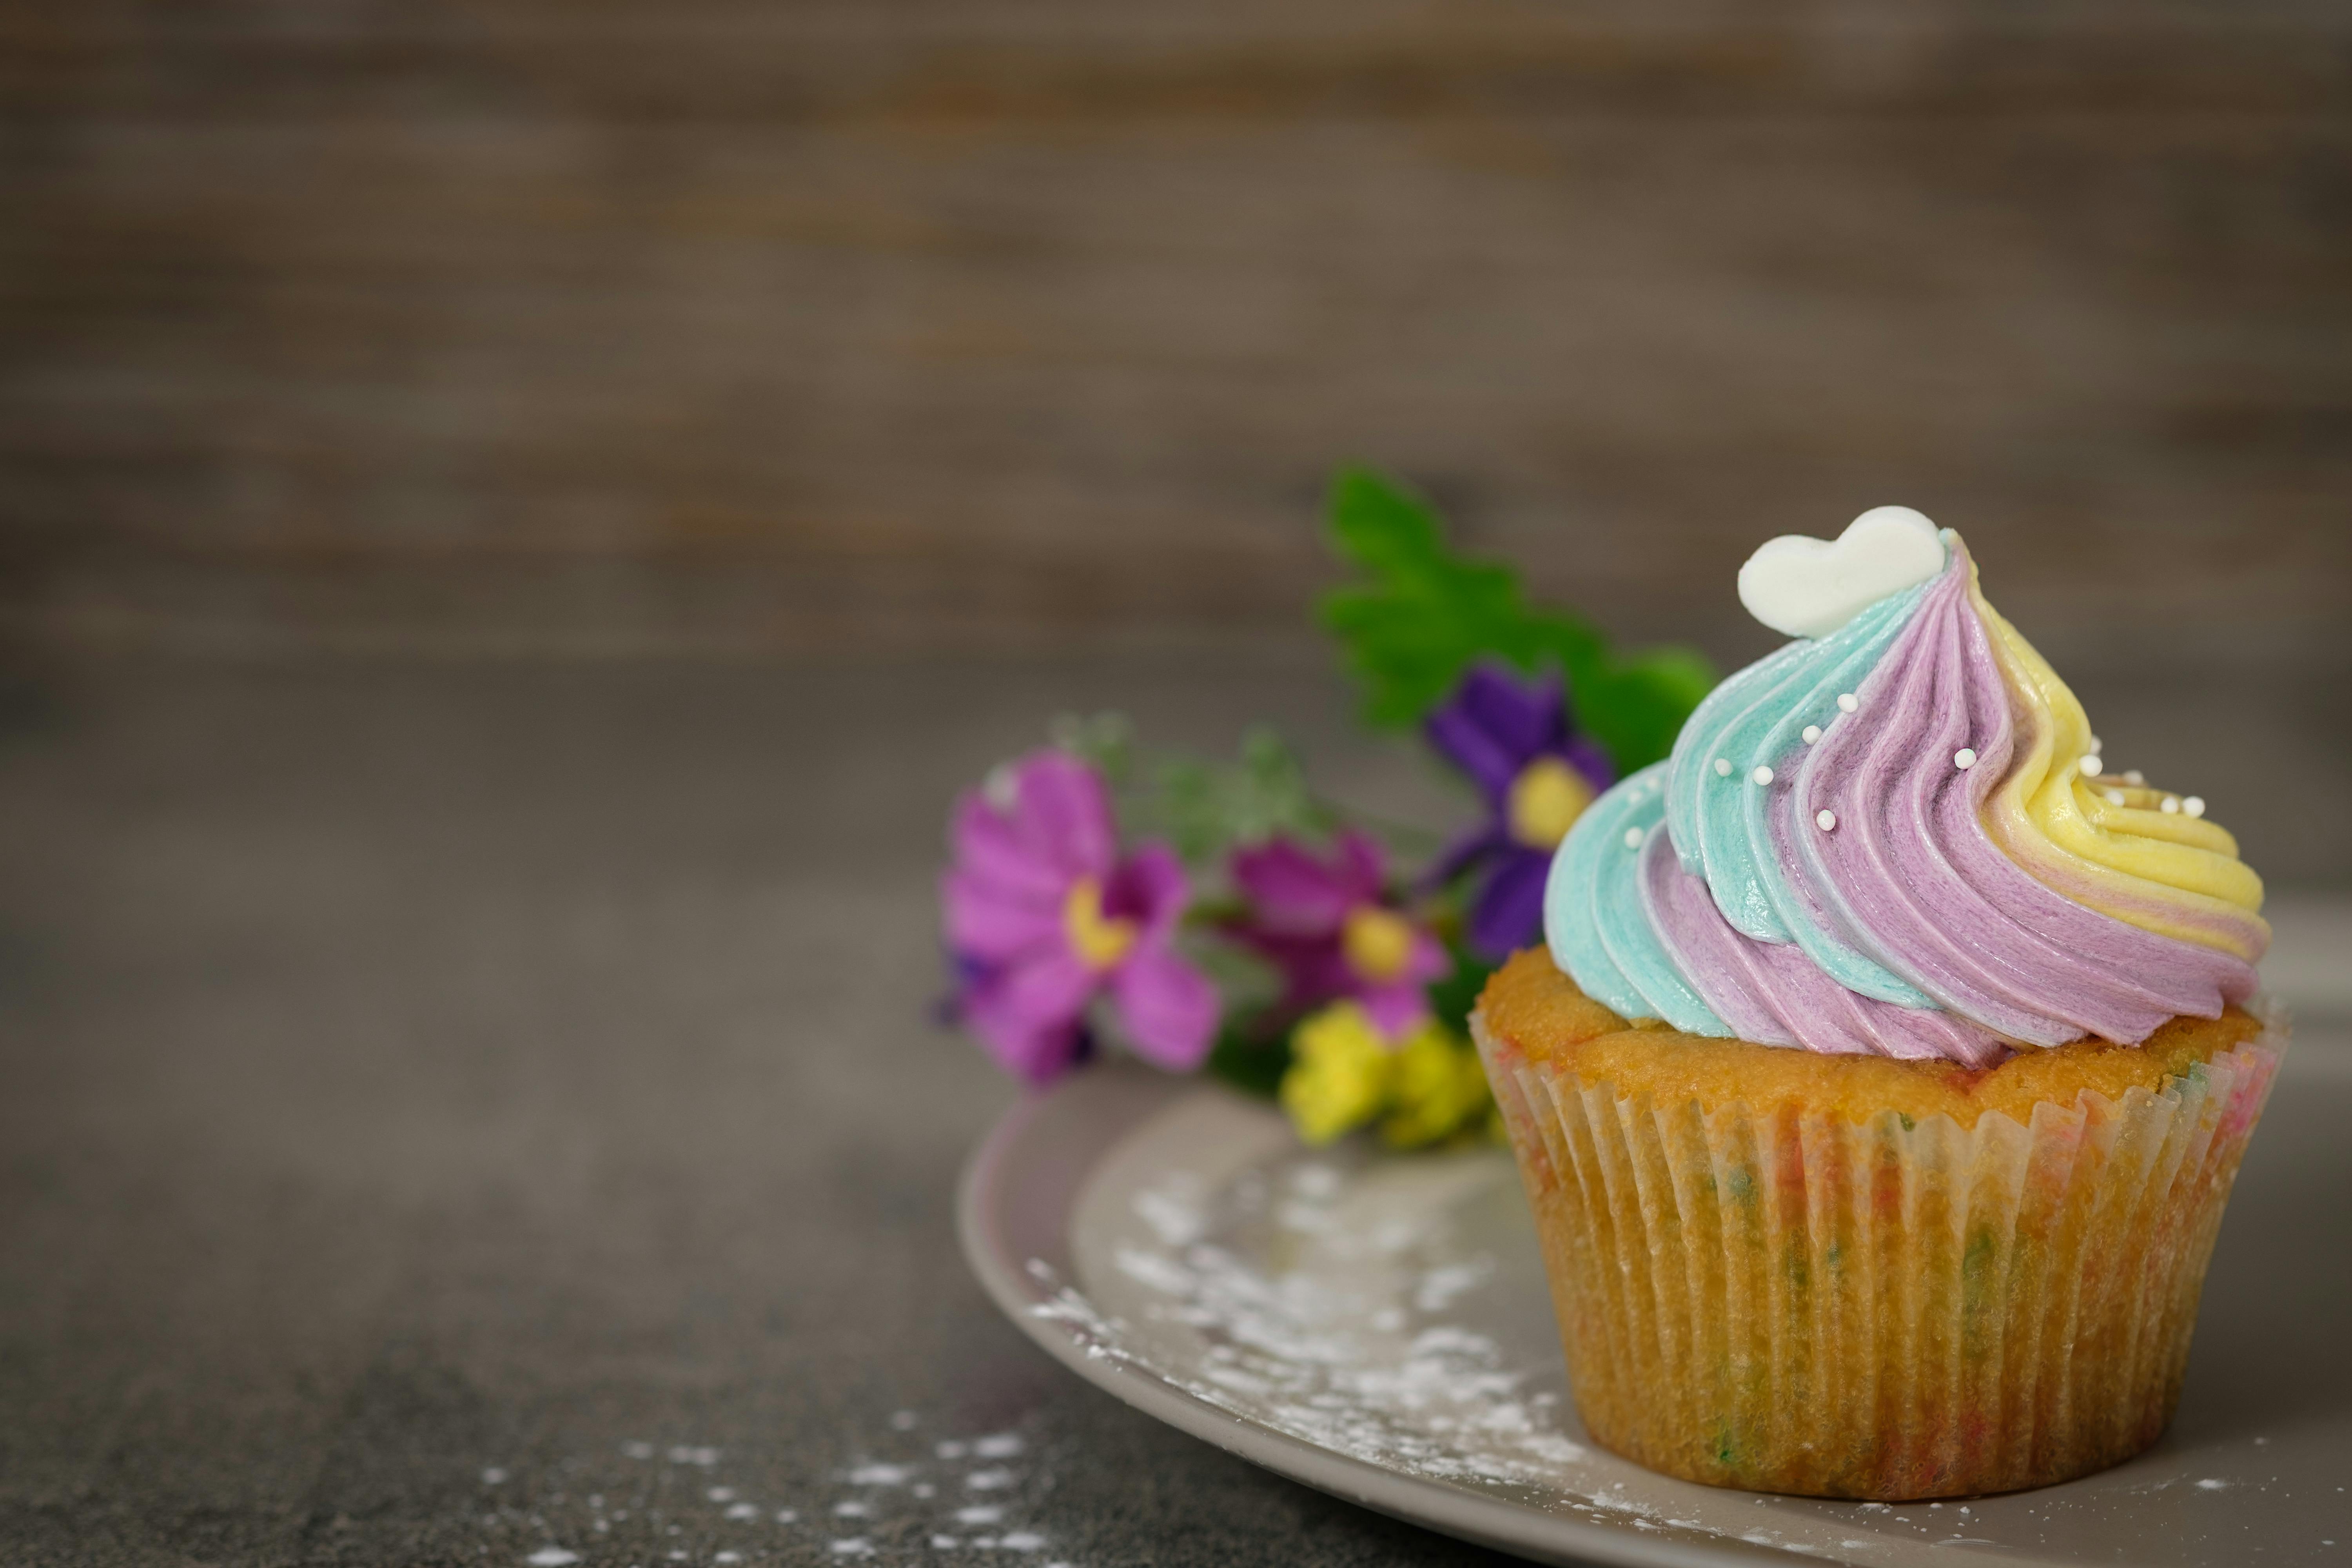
[1472, 508, 2286, 1500]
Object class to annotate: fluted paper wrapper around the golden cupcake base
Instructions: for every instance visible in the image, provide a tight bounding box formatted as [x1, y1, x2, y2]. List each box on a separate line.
[1472, 1018, 2286, 1500]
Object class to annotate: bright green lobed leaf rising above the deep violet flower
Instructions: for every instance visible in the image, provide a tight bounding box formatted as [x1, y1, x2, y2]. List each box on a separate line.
[1319, 468, 1715, 773]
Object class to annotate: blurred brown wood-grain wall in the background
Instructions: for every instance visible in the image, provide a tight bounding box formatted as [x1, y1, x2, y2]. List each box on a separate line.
[0, 0, 2352, 663]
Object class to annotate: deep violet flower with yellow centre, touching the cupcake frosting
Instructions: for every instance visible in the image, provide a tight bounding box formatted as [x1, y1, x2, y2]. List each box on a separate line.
[1425, 665, 1616, 962]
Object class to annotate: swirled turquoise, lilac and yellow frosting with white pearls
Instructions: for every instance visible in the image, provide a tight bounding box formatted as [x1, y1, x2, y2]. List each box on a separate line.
[1545, 522, 2270, 1065]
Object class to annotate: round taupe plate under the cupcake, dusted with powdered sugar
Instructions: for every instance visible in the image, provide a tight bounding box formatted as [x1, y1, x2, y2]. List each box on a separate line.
[960, 1039, 2352, 1568]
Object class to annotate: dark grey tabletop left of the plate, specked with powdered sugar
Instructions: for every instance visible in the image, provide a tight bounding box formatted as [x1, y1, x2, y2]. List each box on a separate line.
[0, 661, 2333, 1568]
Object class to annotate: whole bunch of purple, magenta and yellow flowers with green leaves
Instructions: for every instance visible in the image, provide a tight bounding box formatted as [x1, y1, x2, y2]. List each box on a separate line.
[941, 470, 1715, 1147]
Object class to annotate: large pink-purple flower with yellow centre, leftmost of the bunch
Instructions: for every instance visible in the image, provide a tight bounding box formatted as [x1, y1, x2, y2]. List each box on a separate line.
[938, 752, 1218, 1084]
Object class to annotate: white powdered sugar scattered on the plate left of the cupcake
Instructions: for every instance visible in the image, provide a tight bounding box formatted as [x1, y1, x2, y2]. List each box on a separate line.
[1058, 1123, 1621, 1507]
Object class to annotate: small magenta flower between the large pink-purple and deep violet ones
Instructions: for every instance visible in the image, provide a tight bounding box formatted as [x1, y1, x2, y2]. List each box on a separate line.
[1228, 832, 1451, 1039]
